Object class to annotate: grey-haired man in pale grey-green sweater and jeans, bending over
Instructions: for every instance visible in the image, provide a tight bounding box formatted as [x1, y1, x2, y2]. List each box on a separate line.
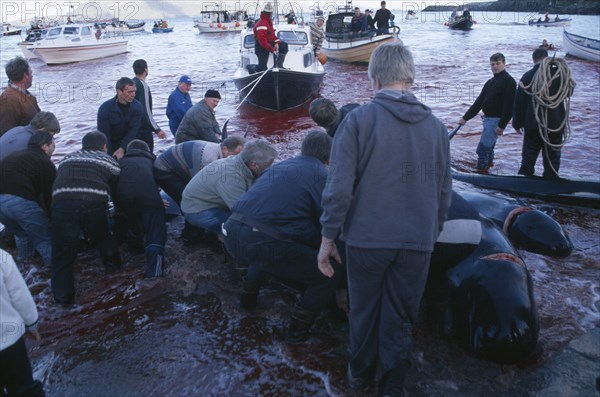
[181, 140, 277, 235]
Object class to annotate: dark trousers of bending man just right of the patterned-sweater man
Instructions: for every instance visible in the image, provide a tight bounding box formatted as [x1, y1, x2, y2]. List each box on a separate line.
[126, 210, 167, 277]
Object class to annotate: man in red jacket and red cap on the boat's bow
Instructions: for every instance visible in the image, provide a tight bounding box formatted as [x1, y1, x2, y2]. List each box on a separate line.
[254, 3, 288, 72]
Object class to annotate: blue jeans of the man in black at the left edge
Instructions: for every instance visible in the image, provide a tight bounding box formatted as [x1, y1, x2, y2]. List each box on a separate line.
[0, 194, 52, 266]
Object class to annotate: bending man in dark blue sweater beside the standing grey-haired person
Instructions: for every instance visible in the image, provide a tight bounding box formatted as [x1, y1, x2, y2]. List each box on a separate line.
[223, 131, 344, 343]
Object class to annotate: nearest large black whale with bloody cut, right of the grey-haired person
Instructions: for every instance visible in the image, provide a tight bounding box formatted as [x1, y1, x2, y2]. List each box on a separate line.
[426, 193, 539, 363]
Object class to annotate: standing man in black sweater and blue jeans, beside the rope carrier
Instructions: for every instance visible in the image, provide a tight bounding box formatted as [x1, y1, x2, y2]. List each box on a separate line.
[458, 53, 517, 173]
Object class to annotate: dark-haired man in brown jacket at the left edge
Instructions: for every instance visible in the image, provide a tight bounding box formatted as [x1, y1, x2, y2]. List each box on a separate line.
[0, 57, 40, 136]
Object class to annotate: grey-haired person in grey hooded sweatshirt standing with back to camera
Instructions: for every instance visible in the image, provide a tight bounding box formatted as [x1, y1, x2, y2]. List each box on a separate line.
[318, 42, 452, 396]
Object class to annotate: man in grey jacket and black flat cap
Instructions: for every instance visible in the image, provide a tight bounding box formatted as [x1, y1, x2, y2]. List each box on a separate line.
[175, 90, 221, 143]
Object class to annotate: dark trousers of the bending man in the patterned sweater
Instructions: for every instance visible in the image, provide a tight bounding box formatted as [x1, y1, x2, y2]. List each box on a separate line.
[51, 200, 120, 303]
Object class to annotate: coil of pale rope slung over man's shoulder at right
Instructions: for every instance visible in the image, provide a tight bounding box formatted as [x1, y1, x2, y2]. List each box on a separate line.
[519, 57, 575, 175]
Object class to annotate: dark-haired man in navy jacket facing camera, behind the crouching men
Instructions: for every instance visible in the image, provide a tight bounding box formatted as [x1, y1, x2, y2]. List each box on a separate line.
[97, 77, 142, 159]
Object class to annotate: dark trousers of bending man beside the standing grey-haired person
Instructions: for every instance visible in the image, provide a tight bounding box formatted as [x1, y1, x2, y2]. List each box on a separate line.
[224, 219, 345, 315]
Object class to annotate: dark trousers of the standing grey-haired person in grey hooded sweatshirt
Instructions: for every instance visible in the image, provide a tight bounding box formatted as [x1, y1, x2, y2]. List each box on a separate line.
[346, 246, 431, 379]
